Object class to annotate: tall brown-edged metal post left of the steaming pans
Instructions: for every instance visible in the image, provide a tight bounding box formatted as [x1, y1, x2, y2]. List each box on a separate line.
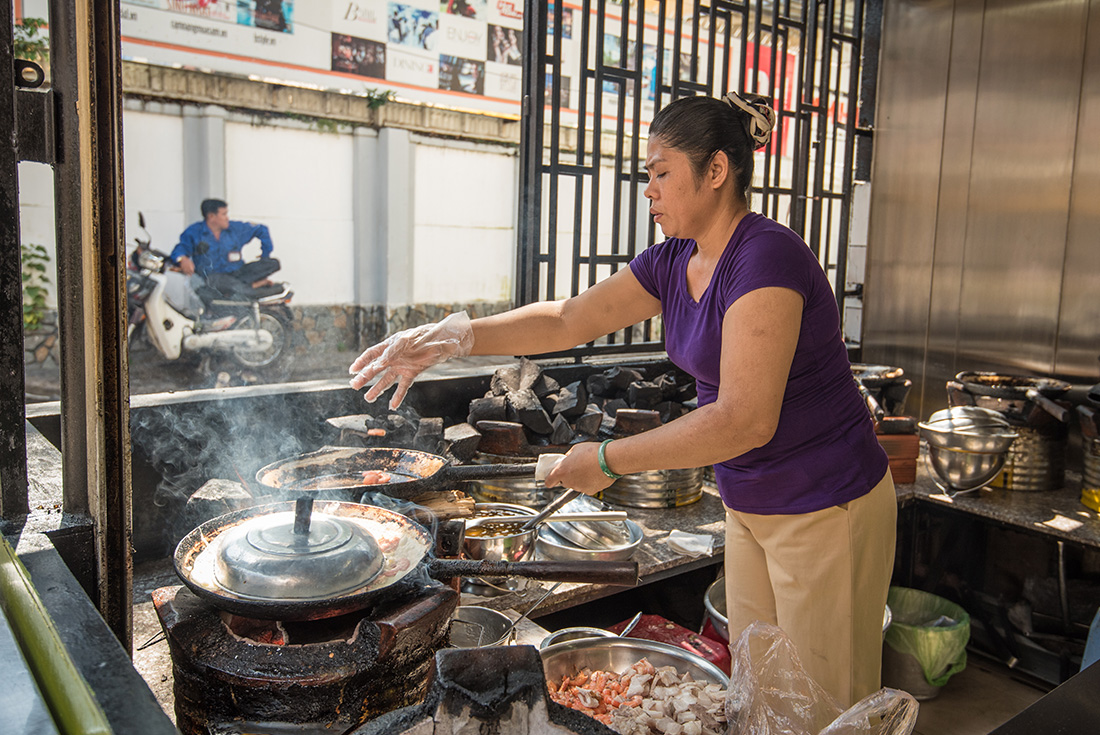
[50, 0, 133, 651]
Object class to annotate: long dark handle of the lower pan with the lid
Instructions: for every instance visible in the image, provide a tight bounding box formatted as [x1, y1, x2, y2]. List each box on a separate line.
[428, 559, 638, 586]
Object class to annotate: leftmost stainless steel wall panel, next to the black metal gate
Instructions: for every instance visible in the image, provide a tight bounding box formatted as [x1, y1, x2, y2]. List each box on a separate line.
[864, 0, 954, 413]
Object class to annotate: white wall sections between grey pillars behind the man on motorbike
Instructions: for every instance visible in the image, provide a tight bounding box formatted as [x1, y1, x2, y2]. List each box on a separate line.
[20, 100, 518, 306]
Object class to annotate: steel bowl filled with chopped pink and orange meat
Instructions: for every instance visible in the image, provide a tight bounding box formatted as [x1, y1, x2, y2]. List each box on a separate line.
[539, 637, 729, 735]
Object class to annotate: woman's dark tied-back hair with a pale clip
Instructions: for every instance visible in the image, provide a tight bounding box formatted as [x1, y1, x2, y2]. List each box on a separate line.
[649, 92, 776, 201]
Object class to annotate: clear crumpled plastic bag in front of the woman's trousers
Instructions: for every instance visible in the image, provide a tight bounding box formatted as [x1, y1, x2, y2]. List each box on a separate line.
[726, 622, 919, 735]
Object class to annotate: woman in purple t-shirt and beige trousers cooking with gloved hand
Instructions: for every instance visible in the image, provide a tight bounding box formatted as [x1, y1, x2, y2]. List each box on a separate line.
[351, 92, 897, 706]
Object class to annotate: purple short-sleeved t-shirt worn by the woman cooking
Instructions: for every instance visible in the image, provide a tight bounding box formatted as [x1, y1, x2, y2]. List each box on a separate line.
[630, 212, 888, 515]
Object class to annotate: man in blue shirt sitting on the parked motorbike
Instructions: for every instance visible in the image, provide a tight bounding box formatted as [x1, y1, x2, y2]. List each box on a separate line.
[172, 199, 279, 294]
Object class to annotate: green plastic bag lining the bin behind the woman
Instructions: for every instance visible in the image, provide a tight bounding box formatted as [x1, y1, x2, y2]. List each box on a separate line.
[887, 586, 970, 687]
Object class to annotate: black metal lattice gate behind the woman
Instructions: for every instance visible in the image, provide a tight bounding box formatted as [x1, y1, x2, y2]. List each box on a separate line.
[517, 0, 881, 356]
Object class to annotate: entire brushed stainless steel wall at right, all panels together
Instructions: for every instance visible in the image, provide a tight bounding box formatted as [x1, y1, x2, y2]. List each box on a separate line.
[862, 0, 1100, 416]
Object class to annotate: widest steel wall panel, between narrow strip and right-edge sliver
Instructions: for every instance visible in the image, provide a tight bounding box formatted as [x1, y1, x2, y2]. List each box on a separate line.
[953, 0, 1088, 373]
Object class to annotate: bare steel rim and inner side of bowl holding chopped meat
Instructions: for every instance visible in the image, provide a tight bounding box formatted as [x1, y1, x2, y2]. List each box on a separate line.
[539, 636, 729, 687]
